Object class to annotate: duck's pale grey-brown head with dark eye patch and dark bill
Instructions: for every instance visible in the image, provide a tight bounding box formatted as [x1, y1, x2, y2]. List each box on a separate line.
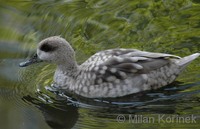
[20, 36, 75, 67]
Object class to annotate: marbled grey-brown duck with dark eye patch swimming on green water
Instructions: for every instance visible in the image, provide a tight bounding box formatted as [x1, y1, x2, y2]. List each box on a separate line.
[19, 36, 200, 98]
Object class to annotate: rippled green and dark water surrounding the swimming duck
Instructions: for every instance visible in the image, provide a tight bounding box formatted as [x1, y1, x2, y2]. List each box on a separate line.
[0, 0, 200, 129]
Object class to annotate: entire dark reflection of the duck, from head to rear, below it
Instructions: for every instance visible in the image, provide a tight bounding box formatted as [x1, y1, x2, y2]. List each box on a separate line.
[20, 81, 193, 129]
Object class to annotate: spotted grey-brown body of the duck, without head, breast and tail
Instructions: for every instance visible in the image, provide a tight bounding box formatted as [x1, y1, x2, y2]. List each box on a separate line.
[76, 49, 197, 98]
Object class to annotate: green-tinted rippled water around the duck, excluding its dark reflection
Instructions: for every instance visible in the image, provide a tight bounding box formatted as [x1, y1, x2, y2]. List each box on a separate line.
[0, 0, 200, 129]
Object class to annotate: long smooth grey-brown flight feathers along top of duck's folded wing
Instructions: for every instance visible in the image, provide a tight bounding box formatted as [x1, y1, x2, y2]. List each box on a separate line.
[100, 49, 180, 73]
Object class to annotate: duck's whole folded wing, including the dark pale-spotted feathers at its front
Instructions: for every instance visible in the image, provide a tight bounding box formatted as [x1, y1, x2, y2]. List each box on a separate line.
[82, 49, 180, 81]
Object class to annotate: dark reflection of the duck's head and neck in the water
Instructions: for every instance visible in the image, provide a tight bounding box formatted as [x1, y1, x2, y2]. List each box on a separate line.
[22, 95, 78, 129]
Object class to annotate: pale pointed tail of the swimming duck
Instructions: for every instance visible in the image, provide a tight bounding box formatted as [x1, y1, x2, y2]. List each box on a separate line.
[177, 53, 200, 69]
